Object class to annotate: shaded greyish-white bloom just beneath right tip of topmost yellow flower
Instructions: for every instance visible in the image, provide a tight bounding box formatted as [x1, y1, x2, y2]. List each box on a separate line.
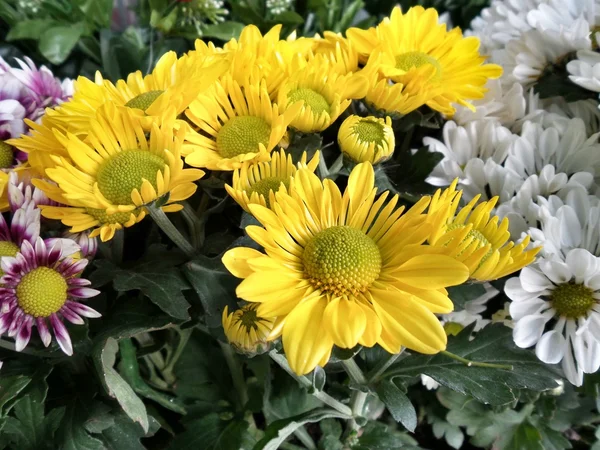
[452, 79, 527, 127]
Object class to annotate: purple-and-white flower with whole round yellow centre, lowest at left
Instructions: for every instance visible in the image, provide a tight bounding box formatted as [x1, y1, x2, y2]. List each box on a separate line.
[0, 238, 100, 355]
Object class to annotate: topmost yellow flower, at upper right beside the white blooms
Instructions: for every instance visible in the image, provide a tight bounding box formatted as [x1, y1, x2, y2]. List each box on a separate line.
[347, 6, 502, 115]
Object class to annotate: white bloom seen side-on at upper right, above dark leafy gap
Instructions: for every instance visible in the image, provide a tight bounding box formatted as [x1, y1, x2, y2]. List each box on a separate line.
[493, 19, 592, 87]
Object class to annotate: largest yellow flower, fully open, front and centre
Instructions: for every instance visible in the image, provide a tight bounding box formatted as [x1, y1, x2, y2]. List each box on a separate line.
[223, 163, 468, 374]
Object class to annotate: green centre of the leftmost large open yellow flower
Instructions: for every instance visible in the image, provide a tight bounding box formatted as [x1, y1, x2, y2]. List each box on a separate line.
[97, 150, 165, 205]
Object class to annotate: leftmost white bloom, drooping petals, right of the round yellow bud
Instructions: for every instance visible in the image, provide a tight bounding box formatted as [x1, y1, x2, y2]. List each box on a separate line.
[423, 121, 517, 186]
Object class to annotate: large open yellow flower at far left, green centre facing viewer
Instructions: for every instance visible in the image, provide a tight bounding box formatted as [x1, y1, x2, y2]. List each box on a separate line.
[34, 104, 204, 241]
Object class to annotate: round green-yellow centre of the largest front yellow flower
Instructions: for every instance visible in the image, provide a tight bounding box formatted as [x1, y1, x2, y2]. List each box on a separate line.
[302, 226, 381, 296]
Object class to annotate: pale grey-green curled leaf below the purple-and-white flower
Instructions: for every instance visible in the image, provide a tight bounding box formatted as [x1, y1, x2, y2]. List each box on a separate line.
[93, 337, 149, 431]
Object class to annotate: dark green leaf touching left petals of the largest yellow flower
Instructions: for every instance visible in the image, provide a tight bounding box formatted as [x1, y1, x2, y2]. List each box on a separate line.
[182, 255, 239, 327]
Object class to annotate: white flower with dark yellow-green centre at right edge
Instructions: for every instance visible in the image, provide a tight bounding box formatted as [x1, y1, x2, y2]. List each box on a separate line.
[505, 249, 600, 386]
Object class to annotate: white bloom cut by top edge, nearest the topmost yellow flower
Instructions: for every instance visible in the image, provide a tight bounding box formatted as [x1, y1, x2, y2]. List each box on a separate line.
[471, 0, 544, 52]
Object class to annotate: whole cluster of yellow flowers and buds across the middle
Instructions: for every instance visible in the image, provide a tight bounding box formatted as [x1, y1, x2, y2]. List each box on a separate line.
[11, 7, 537, 374]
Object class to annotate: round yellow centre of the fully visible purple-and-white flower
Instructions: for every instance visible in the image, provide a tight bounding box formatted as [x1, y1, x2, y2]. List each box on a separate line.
[17, 267, 67, 317]
